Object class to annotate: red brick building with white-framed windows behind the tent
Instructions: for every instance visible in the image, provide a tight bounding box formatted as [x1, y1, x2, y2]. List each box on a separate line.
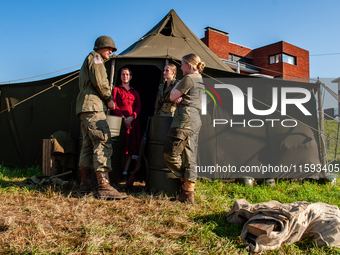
[201, 27, 309, 81]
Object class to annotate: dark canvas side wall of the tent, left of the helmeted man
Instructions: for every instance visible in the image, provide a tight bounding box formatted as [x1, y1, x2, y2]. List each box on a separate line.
[0, 72, 80, 167]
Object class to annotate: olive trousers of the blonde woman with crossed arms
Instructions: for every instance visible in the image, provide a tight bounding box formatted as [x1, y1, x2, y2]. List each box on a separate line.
[164, 128, 199, 182]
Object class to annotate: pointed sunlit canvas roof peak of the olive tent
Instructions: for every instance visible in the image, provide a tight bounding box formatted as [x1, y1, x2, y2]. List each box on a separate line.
[117, 10, 234, 72]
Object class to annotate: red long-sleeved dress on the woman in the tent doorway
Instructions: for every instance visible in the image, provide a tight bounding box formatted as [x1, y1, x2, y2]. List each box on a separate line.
[112, 85, 141, 155]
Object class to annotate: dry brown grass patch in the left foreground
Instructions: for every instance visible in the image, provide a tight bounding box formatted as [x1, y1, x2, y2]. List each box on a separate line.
[0, 182, 231, 254]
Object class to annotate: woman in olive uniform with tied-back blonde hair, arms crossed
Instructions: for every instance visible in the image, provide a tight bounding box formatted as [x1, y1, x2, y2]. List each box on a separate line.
[164, 54, 205, 204]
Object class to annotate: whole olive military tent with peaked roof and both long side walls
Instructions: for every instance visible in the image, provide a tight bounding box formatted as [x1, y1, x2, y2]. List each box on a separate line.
[0, 10, 320, 178]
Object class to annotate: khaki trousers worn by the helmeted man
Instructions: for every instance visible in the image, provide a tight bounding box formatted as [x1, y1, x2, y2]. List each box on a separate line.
[79, 112, 112, 172]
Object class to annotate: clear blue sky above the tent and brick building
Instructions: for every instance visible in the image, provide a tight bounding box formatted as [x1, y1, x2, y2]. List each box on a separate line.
[0, 0, 340, 108]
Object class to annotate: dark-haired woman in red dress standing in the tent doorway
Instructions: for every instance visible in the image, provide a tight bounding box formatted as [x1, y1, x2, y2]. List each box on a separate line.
[112, 68, 141, 176]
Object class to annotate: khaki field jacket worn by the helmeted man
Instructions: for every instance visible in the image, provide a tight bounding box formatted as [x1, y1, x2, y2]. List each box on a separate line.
[76, 52, 112, 115]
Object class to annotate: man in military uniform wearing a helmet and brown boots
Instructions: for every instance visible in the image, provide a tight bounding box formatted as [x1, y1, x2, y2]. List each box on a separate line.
[76, 36, 127, 199]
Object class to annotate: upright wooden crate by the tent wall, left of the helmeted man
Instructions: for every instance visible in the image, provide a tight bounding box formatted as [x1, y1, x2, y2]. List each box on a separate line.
[42, 139, 58, 176]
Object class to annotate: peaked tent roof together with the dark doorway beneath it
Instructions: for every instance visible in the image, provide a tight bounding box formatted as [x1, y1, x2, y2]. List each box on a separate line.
[107, 10, 237, 143]
